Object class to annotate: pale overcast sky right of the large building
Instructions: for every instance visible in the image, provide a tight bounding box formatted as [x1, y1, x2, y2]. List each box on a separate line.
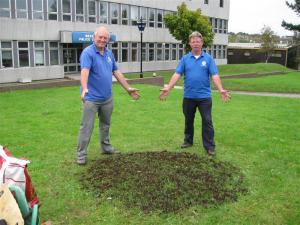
[228, 0, 300, 36]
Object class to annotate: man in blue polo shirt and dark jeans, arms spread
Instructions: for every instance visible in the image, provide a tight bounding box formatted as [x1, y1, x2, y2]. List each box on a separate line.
[160, 31, 230, 155]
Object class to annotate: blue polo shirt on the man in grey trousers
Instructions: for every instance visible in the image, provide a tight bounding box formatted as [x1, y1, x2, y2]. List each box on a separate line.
[80, 43, 118, 102]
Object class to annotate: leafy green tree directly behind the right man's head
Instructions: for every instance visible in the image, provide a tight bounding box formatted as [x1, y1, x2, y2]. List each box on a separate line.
[164, 3, 214, 51]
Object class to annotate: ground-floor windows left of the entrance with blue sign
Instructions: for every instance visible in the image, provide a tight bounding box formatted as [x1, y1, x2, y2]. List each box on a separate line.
[0, 41, 59, 68]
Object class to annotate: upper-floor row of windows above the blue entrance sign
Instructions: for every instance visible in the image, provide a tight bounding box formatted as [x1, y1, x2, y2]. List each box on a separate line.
[0, 0, 228, 33]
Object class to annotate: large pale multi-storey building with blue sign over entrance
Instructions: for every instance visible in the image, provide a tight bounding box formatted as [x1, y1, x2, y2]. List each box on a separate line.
[0, 0, 230, 83]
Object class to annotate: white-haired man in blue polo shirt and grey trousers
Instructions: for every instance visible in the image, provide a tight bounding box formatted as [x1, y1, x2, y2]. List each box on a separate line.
[76, 26, 139, 165]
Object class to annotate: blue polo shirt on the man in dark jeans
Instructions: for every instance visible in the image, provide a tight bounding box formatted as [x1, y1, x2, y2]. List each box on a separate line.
[176, 51, 218, 99]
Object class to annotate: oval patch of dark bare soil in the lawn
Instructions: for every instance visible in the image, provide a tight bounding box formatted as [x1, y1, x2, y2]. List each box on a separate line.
[82, 151, 247, 213]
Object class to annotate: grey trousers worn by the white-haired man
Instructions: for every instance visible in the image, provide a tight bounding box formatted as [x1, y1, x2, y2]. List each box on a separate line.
[77, 97, 114, 162]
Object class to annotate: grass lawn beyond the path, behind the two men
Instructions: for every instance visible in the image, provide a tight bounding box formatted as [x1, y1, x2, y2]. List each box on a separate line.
[126, 63, 300, 93]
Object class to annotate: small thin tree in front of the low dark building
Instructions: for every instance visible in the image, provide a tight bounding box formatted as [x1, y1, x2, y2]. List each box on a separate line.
[260, 26, 277, 63]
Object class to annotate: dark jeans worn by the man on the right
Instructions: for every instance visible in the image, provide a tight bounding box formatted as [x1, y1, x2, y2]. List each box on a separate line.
[182, 98, 215, 150]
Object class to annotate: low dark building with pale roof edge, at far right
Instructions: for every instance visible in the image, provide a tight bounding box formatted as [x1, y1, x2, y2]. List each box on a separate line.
[227, 43, 288, 66]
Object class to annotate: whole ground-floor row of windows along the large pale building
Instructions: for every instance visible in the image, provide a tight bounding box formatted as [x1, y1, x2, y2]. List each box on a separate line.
[0, 41, 227, 68]
